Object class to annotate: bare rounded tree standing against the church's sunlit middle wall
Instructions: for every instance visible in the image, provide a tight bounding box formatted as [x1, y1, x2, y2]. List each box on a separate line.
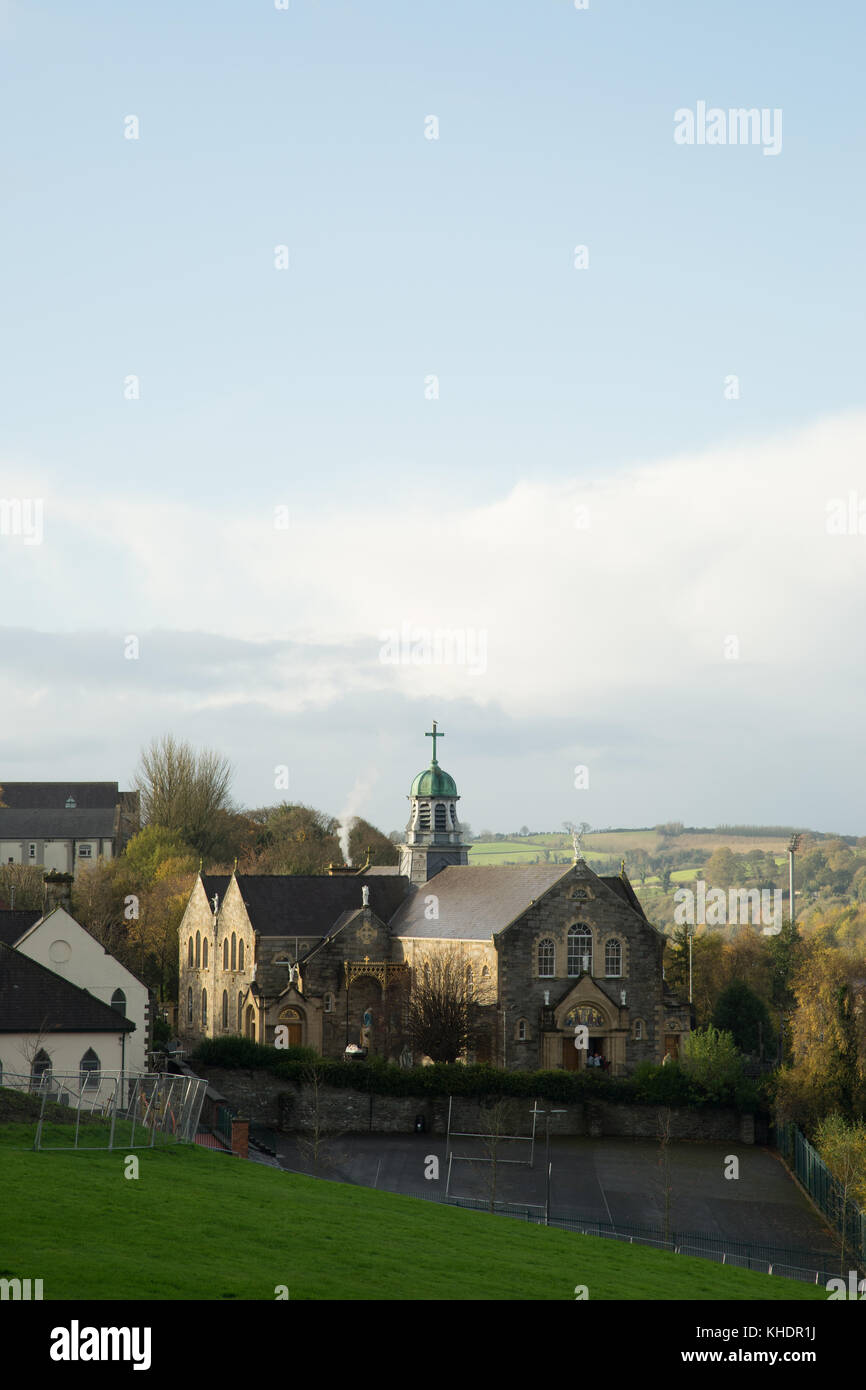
[407, 947, 493, 1062]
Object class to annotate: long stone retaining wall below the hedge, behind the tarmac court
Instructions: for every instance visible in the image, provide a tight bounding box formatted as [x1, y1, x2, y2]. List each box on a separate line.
[197, 1066, 755, 1144]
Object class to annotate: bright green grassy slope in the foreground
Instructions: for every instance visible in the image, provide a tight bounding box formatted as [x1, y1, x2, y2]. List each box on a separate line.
[0, 1125, 826, 1300]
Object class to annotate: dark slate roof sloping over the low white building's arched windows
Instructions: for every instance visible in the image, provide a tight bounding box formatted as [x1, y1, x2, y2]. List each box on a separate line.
[0, 942, 135, 1033]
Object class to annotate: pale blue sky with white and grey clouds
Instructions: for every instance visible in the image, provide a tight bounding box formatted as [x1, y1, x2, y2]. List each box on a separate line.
[0, 0, 866, 834]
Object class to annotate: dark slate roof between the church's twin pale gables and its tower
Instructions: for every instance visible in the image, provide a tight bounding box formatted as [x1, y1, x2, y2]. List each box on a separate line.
[202, 873, 409, 937]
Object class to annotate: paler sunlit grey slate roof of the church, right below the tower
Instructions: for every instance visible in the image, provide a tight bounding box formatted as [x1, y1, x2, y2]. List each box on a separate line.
[389, 865, 573, 941]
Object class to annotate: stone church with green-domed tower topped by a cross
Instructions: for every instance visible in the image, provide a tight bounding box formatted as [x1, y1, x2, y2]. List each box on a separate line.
[178, 721, 691, 1074]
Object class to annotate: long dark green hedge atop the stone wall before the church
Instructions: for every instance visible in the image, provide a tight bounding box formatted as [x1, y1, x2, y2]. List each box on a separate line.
[190, 1038, 760, 1111]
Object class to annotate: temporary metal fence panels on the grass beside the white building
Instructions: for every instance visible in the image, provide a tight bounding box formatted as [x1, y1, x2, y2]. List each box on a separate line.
[3, 1072, 207, 1150]
